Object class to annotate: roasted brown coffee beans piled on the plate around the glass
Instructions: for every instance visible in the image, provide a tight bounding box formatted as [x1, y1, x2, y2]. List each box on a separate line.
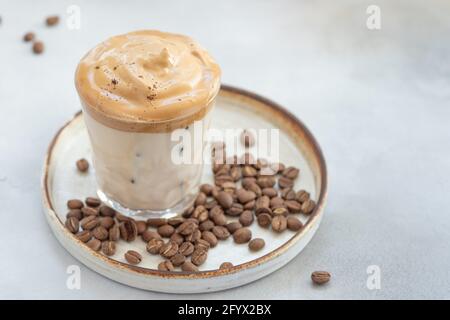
[66, 131, 315, 272]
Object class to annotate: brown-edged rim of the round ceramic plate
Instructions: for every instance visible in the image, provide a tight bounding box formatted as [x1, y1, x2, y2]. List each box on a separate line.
[42, 84, 327, 279]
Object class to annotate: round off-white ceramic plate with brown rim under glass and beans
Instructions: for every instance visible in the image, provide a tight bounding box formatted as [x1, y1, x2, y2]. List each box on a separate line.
[42, 86, 327, 293]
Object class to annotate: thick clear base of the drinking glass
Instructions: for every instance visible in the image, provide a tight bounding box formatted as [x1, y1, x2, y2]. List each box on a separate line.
[97, 189, 196, 219]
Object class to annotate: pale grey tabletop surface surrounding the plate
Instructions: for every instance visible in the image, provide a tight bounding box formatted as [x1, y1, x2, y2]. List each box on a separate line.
[0, 0, 450, 299]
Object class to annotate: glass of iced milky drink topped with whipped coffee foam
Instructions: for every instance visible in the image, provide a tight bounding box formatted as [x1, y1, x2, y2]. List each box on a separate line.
[75, 30, 220, 214]
